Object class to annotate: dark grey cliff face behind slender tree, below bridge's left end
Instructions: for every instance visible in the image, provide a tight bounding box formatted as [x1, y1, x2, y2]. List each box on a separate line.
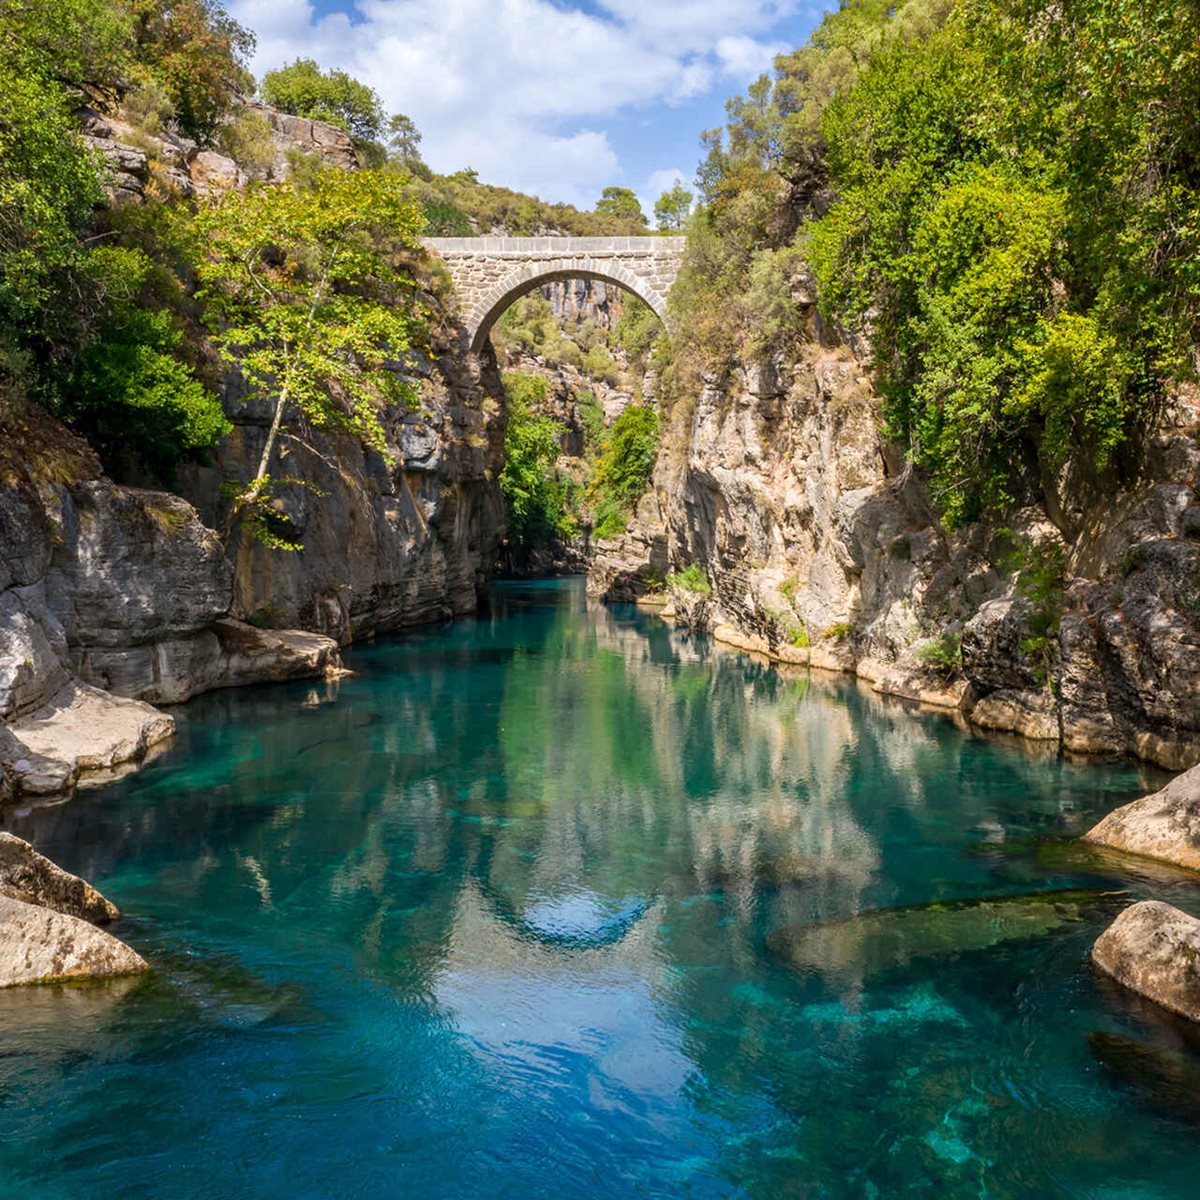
[179, 352, 504, 644]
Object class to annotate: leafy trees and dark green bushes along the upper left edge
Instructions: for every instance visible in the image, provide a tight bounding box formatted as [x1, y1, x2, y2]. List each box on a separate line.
[0, 0, 252, 456]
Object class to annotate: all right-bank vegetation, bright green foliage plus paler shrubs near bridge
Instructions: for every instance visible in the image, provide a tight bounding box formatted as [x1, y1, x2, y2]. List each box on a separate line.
[668, 0, 1200, 524]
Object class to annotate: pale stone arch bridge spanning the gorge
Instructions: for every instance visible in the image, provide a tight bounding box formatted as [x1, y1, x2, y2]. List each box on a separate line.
[425, 238, 688, 352]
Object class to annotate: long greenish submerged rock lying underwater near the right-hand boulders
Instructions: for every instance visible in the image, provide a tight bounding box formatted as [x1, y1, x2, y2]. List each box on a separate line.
[767, 889, 1116, 976]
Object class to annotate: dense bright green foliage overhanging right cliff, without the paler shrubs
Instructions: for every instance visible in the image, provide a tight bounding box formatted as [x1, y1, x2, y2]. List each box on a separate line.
[812, 0, 1200, 523]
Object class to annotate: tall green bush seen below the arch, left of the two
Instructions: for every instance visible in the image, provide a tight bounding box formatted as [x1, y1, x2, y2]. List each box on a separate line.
[500, 371, 580, 550]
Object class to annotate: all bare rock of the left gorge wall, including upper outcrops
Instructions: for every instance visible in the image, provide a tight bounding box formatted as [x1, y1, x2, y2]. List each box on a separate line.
[0, 106, 504, 802]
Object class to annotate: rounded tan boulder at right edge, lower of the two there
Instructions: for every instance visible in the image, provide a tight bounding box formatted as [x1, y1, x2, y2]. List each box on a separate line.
[1092, 900, 1200, 1021]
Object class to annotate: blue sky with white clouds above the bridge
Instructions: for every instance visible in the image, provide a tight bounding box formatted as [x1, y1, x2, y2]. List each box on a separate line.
[227, 0, 830, 216]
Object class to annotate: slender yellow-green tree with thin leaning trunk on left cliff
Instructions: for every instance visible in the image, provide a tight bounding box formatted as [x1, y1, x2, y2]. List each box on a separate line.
[193, 168, 425, 545]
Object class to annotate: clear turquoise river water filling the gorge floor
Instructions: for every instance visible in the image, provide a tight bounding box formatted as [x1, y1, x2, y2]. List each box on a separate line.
[0, 582, 1200, 1200]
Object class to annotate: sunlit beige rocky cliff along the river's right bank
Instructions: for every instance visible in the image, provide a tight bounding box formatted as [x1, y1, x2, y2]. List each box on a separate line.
[589, 340, 1200, 768]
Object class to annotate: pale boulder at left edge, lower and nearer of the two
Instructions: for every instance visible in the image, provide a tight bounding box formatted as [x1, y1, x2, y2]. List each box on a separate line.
[0, 895, 149, 988]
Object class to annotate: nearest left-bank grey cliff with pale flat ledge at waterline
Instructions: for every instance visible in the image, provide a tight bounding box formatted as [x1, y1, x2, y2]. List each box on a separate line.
[0, 407, 340, 798]
